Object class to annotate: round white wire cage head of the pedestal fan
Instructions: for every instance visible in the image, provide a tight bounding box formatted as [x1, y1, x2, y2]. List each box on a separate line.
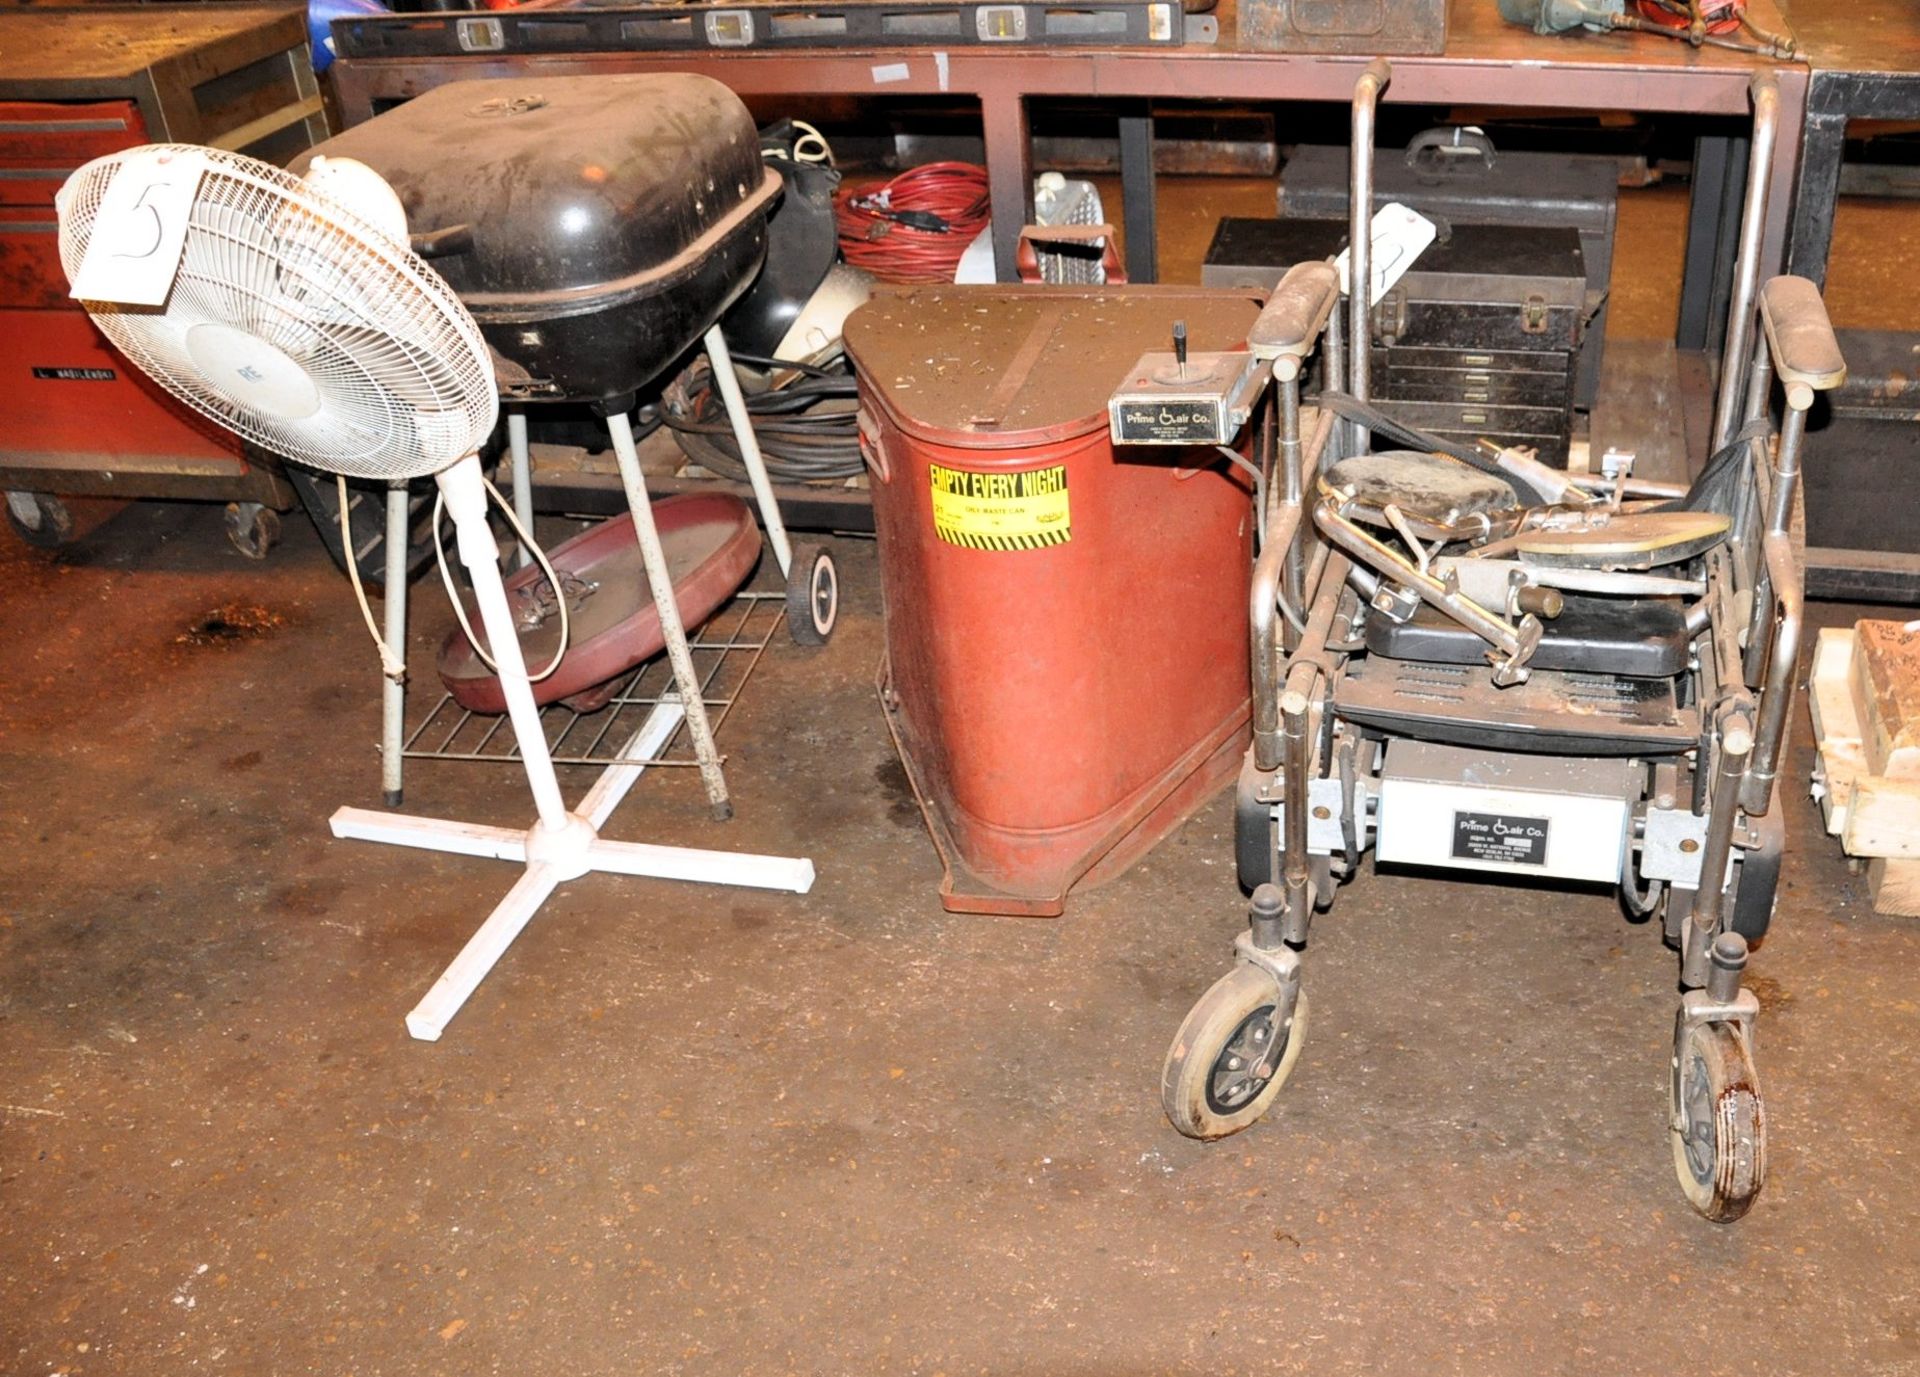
[58, 144, 499, 478]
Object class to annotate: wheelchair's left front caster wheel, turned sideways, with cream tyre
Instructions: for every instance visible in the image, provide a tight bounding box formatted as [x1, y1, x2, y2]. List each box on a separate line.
[1160, 966, 1308, 1139]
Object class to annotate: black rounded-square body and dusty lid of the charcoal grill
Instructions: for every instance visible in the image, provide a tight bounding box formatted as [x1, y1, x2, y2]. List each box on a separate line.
[292, 73, 781, 401]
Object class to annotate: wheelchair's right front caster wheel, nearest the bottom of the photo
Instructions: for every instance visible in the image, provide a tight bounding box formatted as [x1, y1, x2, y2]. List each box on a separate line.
[1670, 1024, 1766, 1223]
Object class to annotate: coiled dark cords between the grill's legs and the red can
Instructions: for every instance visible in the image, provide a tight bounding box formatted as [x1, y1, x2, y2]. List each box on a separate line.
[660, 353, 866, 482]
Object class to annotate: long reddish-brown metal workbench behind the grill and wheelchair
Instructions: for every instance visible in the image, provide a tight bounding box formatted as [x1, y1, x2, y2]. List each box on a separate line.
[322, 0, 1807, 282]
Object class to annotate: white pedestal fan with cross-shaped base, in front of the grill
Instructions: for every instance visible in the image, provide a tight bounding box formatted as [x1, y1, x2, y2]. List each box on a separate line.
[58, 144, 814, 1039]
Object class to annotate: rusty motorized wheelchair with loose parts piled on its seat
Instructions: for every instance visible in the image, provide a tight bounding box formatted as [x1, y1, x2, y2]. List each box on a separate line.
[1162, 61, 1845, 1221]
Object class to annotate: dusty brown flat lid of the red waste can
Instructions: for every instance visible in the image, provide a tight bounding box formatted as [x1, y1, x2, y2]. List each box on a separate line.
[845, 286, 1261, 449]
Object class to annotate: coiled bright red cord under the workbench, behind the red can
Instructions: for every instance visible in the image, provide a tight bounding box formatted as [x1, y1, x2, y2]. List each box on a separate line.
[833, 163, 993, 282]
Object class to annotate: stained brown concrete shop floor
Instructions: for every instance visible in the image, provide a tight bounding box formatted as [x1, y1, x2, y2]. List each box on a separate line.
[0, 185, 1920, 1377]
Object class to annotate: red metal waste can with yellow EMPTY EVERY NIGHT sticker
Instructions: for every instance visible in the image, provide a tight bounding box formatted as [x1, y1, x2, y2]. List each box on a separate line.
[847, 286, 1258, 916]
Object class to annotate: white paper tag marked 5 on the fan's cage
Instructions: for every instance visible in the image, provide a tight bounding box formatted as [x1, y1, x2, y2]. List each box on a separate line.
[67, 150, 207, 305]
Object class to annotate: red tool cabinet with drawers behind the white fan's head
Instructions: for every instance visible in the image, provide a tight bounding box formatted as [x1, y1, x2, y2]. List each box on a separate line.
[0, 6, 326, 540]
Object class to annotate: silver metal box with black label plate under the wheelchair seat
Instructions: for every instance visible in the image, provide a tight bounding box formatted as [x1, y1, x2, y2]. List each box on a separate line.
[1375, 741, 1644, 883]
